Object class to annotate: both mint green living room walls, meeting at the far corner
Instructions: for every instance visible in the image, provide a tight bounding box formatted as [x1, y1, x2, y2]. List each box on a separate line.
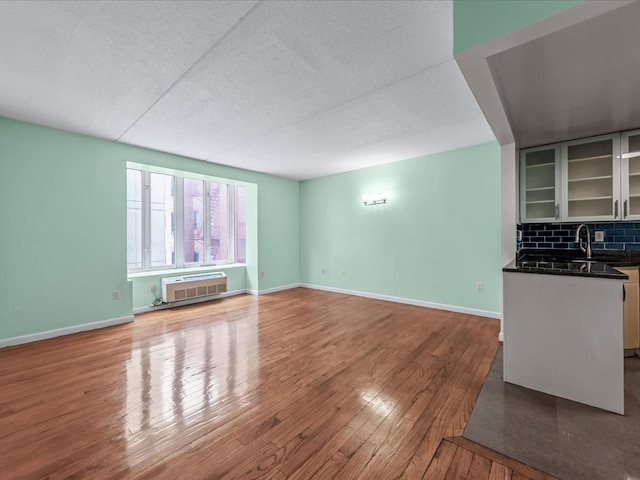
[0, 113, 500, 340]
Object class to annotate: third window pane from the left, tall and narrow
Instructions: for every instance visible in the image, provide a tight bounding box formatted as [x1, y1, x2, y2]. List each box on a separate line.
[184, 178, 204, 263]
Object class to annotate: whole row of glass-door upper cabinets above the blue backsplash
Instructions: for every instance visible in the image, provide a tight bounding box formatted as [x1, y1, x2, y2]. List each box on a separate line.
[520, 130, 640, 223]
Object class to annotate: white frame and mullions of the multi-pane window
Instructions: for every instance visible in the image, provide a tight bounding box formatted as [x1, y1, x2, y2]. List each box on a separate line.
[127, 165, 246, 273]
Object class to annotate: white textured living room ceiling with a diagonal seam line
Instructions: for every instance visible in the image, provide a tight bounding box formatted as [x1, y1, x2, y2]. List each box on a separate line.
[0, 0, 494, 180]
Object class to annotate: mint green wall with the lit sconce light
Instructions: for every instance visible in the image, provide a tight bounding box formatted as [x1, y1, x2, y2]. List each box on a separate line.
[300, 143, 501, 312]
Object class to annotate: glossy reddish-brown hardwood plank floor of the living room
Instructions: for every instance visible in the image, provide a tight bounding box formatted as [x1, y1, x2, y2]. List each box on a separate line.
[0, 288, 516, 480]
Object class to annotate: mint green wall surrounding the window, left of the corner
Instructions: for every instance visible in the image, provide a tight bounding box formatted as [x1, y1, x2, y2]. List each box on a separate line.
[0, 117, 300, 339]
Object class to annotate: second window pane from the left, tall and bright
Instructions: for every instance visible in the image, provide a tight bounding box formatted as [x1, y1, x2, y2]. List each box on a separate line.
[149, 173, 176, 267]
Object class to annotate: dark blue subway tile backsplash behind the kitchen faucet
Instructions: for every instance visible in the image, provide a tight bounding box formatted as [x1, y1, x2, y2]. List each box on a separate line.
[518, 222, 640, 250]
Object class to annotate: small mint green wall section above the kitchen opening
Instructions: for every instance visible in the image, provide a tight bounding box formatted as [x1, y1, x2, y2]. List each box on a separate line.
[453, 0, 585, 53]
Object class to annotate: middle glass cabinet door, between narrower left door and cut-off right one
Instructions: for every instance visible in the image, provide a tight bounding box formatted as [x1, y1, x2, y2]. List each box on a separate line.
[562, 135, 616, 222]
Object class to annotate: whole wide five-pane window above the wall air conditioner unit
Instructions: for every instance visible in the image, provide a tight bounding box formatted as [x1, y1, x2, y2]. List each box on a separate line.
[127, 168, 246, 271]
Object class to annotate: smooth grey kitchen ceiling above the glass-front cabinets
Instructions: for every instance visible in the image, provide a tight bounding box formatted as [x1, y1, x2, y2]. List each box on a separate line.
[487, 2, 640, 148]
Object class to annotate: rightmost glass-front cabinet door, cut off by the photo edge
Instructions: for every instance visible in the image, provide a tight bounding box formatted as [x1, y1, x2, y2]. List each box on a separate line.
[620, 130, 640, 220]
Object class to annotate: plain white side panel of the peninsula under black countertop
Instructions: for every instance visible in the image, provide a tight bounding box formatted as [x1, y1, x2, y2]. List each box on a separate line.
[503, 272, 624, 414]
